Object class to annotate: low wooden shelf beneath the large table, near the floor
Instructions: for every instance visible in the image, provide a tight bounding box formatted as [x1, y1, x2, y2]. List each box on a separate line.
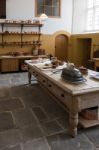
[79, 117, 99, 128]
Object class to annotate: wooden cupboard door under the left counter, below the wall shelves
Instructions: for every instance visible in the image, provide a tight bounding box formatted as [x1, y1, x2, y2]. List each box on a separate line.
[1, 59, 19, 72]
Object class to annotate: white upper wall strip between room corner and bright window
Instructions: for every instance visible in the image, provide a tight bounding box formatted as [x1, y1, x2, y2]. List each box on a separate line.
[72, 0, 87, 34]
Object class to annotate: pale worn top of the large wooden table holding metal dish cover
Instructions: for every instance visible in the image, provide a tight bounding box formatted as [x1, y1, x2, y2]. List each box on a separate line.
[25, 60, 99, 95]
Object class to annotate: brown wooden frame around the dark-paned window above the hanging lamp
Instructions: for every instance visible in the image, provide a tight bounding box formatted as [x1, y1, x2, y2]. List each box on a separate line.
[35, 0, 61, 18]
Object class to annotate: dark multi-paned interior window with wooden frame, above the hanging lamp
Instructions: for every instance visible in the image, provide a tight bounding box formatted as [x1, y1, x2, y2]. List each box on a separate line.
[35, 0, 60, 17]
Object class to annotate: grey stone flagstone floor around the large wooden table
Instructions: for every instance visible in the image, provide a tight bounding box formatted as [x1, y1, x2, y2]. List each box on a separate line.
[0, 73, 99, 150]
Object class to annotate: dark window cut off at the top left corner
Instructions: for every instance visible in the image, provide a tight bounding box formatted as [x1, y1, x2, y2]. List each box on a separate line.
[0, 0, 6, 19]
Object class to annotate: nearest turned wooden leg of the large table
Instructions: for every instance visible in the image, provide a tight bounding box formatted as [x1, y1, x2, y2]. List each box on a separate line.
[69, 112, 78, 137]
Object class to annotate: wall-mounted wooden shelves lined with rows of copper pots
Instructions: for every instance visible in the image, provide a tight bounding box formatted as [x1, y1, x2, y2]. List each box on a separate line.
[0, 20, 43, 47]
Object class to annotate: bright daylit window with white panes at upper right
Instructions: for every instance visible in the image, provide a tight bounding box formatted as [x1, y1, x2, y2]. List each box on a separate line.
[86, 0, 99, 31]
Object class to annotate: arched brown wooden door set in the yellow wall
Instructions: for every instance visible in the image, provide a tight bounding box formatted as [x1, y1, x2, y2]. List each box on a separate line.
[55, 34, 68, 60]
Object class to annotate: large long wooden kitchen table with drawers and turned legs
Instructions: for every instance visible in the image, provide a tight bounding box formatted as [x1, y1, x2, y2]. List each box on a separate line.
[26, 61, 99, 136]
